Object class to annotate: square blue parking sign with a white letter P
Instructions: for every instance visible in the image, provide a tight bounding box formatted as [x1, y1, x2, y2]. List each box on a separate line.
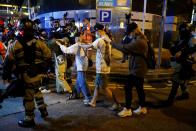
[99, 10, 112, 23]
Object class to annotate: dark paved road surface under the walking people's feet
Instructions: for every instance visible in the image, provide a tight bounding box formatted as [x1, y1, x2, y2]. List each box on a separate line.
[0, 79, 196, 131]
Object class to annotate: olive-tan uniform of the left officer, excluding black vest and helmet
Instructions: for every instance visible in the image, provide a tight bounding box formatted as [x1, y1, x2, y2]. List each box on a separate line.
[4, 39, 51, 126]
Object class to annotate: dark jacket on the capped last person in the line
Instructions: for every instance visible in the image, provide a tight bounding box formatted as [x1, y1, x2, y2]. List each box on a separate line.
[113, 35, 148, 78]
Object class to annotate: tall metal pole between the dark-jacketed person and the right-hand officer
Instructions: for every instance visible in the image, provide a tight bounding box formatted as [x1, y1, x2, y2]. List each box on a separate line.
[157, 0, 167, 69]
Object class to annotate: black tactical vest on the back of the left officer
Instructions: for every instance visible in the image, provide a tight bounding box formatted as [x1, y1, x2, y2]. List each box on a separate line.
[13, 40, 47, 77]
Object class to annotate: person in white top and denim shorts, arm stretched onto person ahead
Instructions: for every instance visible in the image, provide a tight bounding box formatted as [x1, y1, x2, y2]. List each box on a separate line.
[80, 24, 116, 107]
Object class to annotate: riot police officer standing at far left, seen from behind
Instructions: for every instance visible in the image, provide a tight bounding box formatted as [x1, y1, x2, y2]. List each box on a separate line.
[3, 18, 51, 127]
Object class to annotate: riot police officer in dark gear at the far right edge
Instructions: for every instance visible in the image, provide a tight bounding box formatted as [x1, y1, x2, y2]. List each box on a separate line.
[165, 22, 196, 105]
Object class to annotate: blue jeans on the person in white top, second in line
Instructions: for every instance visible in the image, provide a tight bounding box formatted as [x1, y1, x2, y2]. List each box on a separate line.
[76, 71, 91, 100]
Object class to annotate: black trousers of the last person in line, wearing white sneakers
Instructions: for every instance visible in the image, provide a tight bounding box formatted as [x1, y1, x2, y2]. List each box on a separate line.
[124, 75, 145, 109]
